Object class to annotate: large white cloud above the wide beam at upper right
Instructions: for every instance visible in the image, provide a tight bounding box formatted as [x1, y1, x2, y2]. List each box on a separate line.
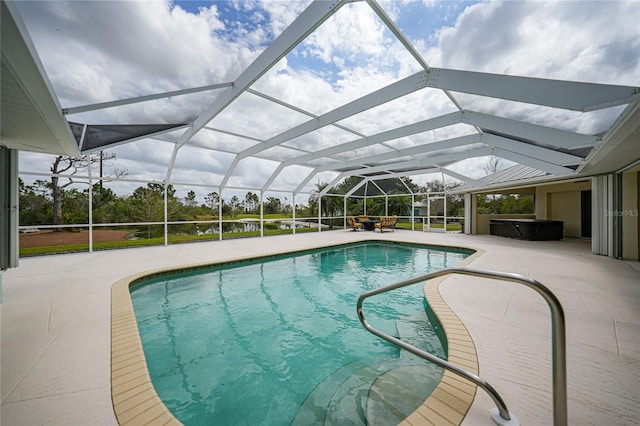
[426, 1, 640, 84]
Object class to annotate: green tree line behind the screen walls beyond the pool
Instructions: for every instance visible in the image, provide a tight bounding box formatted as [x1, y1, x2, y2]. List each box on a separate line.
[19, 178, 462, 230]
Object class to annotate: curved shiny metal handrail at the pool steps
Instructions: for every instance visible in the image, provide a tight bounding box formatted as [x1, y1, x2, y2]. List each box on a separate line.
[357, 268, 567, 426]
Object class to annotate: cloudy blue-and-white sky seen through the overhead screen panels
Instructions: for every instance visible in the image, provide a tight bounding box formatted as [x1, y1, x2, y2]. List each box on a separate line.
[18, 0, 640, 198]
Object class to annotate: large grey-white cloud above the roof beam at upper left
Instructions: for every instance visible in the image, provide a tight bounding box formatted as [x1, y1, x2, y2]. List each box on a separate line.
[19, 1, 250, 106]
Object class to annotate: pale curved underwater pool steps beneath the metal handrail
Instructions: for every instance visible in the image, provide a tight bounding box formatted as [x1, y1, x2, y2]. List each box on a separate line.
[292, 312, 442, 425]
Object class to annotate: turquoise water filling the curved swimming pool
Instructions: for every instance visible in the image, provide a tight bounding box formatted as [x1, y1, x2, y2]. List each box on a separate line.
[131, 242, 470, 425]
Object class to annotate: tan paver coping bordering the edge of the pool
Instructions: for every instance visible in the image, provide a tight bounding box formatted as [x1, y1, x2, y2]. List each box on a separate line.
[111, 240, 484, 426]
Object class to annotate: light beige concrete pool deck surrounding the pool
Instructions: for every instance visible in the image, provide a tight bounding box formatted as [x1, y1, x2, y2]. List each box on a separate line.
[0, 230, 640, 425]
